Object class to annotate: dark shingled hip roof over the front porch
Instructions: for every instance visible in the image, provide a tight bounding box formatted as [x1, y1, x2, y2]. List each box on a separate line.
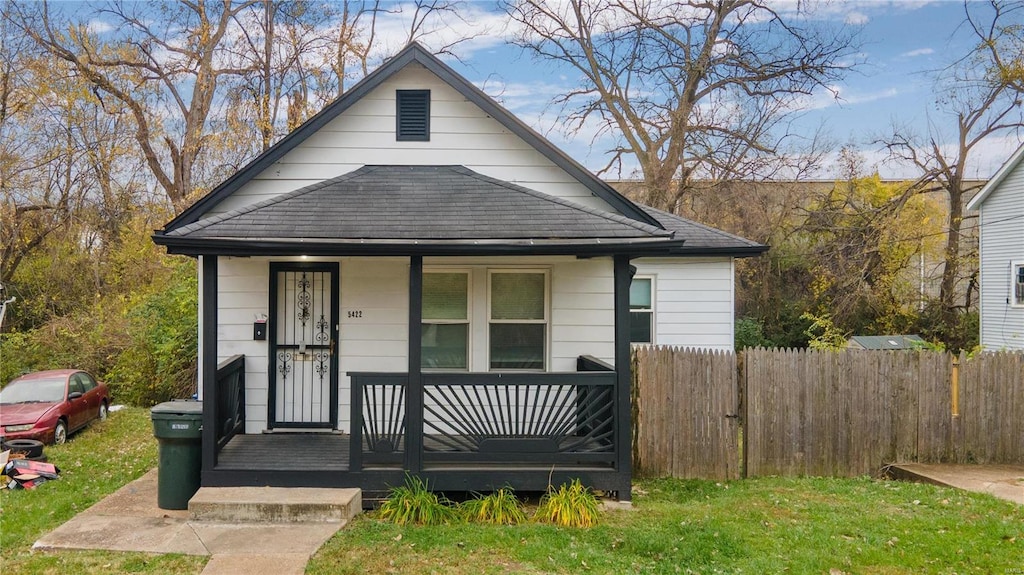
[164, 166, 673, 241]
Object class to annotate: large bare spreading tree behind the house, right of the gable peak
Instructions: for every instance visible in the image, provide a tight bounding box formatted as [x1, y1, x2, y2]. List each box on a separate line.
[505, 0, 857, 211]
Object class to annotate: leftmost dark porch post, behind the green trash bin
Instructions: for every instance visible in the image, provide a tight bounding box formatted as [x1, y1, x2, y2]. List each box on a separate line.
[200, 256, 217, 474]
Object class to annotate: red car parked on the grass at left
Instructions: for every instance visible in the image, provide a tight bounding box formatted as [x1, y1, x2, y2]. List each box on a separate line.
[0, 369, 111, 445]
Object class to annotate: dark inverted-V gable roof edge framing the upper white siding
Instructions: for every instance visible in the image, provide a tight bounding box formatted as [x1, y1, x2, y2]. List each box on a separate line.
[164, 42, 658, 232]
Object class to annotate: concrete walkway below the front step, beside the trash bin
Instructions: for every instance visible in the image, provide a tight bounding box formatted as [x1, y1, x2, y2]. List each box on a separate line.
[33, 470, 358, 575]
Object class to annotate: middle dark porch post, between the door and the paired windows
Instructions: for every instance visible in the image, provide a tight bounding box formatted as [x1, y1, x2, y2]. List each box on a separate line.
[406, 256, 423, 474]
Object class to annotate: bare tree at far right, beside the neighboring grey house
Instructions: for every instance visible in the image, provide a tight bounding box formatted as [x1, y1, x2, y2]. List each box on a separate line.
[879, 0, 1024, 342]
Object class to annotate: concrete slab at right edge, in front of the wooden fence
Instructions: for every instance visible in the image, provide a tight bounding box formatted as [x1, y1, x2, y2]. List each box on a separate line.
[889, 463, 1024, 505]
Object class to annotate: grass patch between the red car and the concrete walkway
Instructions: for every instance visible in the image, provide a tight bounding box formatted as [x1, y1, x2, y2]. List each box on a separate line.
[0, 408, 208, 575]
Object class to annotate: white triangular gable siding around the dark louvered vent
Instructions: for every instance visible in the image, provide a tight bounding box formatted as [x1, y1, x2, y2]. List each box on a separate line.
[208, 64, 613, 215]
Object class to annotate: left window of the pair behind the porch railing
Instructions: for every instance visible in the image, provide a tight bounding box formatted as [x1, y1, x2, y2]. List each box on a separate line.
[421, 272, 469, 369]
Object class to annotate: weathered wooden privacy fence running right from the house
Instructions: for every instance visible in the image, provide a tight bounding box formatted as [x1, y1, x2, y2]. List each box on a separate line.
[633, 347, 1024, 479]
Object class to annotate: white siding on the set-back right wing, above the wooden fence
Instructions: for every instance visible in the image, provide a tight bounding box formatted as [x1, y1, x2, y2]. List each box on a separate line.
[632, 258, 735, 350]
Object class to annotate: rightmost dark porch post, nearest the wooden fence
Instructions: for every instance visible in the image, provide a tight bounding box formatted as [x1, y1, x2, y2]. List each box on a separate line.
[614, 254, 633, 501]
